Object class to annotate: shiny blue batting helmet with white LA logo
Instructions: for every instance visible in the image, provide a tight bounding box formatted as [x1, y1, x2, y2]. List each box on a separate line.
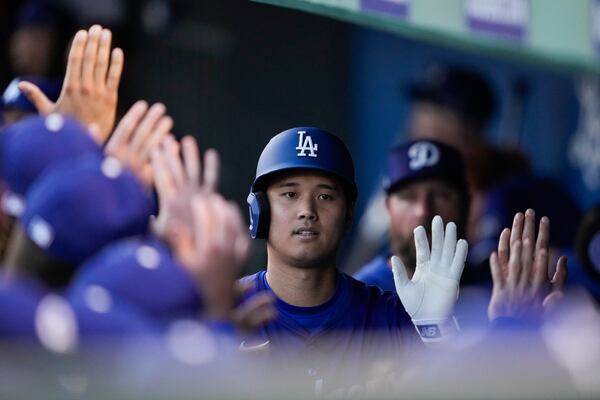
[247, 127, 358, 239]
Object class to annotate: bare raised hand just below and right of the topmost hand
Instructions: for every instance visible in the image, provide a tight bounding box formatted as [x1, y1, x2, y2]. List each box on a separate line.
[104, 101, 171, 188]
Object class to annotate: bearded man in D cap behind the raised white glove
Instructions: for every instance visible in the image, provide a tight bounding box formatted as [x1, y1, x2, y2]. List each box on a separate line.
[355, 140, 476, 291]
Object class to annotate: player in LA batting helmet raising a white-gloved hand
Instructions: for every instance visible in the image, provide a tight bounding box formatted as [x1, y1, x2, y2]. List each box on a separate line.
[240, 127, 467, 388]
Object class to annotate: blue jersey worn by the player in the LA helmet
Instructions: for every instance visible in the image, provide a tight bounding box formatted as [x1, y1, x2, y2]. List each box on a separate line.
[240, 271, 421, 388]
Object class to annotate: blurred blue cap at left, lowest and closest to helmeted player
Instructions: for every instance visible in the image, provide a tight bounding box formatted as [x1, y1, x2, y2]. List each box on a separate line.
[68, 237, 201, 320]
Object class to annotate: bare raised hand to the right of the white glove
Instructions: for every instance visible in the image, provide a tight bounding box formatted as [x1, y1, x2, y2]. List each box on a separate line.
[488, 209, 567, 322]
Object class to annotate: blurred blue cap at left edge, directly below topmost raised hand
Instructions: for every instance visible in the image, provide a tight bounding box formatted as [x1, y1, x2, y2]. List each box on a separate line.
[0, 114, 102, 217]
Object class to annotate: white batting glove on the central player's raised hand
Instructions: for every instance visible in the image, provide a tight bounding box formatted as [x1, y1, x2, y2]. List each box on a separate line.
[392, 215, 468, 342]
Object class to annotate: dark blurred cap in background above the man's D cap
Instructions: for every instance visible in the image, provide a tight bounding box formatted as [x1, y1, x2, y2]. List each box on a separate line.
[408, 65, 495, 124]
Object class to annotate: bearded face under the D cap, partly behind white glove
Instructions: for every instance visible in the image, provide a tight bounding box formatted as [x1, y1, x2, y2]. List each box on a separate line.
[385, 179, 461, 269]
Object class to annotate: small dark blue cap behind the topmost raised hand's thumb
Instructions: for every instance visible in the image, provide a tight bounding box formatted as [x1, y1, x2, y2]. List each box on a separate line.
[0, 76, 62, 114]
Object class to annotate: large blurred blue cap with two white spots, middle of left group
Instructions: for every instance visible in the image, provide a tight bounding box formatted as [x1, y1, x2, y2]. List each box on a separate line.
[21, 156, 152, 264]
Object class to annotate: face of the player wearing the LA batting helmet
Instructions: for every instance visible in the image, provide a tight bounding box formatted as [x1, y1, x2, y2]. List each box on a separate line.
[267, 171, 349, 268]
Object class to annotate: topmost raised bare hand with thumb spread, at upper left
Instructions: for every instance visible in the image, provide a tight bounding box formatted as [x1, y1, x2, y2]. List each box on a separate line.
[19, 25, 124, 144]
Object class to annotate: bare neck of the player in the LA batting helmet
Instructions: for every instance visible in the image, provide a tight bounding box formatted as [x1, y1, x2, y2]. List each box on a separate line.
[267, 263, 337, 307]
